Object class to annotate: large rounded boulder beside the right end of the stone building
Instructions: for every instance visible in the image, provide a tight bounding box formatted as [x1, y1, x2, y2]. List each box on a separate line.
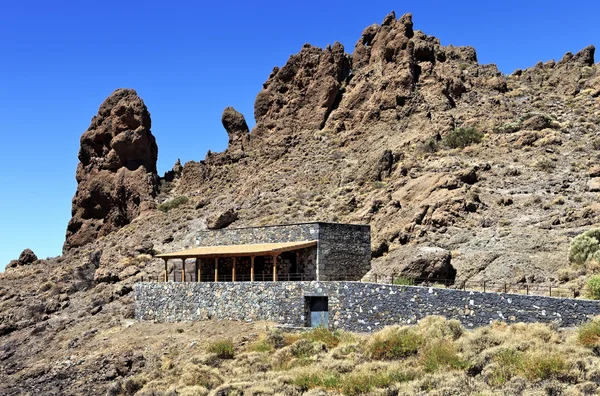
[372, 246, 456, 283]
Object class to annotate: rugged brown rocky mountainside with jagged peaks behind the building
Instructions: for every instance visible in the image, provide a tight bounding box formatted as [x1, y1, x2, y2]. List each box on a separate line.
[0, 13, 600, 394]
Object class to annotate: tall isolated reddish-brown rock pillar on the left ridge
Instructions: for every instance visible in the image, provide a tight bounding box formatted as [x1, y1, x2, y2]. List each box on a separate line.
[63, 89, 158, 251]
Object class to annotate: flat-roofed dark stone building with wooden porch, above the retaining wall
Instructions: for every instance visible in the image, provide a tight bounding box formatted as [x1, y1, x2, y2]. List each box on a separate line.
[157, 222, 371, 282]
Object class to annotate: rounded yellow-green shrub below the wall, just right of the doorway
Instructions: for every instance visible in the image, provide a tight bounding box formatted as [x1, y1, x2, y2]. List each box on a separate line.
[366, 326, 423, 360]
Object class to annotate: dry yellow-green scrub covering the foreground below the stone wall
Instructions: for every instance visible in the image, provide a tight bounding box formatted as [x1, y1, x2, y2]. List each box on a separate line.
[115, 316, 600, 395]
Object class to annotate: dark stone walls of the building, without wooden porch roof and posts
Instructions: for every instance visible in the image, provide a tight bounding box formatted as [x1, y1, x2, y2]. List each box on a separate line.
[187, 223, 371, 280]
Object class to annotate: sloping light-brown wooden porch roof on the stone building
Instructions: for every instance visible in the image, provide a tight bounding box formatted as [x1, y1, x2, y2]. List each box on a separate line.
[156, 241, 317, 259]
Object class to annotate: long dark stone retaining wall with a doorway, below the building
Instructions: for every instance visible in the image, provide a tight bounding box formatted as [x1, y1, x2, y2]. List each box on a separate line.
[135, 282, 600, 331]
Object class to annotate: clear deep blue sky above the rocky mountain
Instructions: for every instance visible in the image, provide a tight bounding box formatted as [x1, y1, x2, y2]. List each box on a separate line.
[0, 0, 600, 270]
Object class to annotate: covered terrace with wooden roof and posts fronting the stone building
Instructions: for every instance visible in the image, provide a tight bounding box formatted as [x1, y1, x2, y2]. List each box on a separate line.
[156, 241, 317, 282]
